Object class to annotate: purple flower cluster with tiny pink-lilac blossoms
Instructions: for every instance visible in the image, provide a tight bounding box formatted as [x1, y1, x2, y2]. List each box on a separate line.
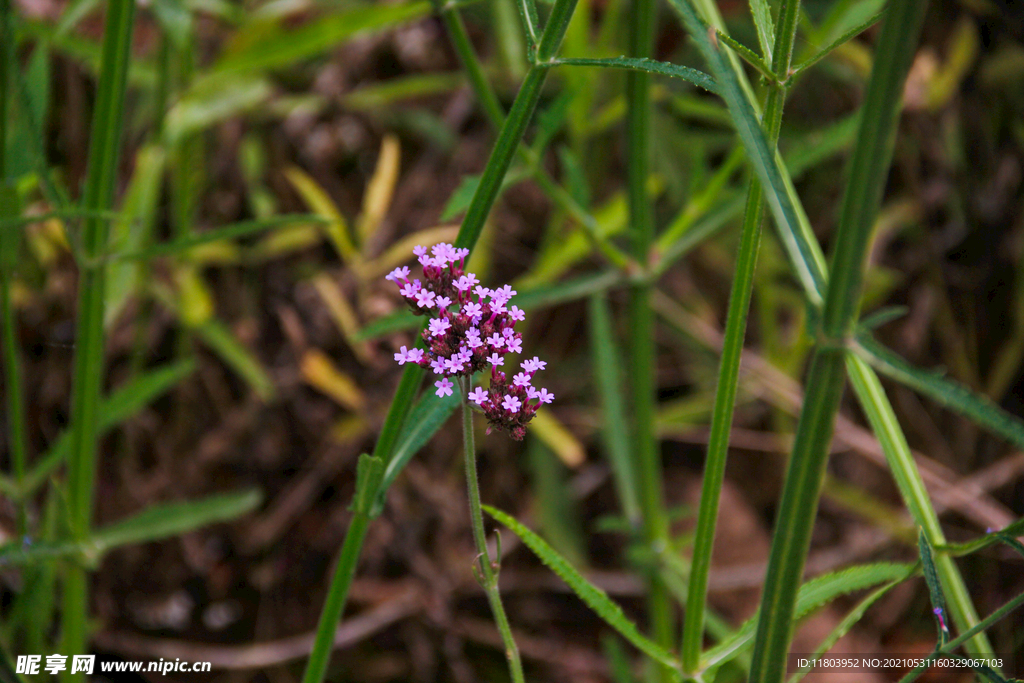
[386, 244, 555, 440]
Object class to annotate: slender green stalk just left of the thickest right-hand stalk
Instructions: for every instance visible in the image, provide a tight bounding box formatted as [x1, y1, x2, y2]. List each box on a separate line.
[682, 0, 800, 674]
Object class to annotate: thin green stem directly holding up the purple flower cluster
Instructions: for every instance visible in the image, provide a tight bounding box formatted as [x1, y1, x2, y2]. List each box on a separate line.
[460, 380, 525, 683]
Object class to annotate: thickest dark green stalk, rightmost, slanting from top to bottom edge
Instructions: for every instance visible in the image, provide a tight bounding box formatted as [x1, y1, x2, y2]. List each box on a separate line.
[751, 0, 927, 683]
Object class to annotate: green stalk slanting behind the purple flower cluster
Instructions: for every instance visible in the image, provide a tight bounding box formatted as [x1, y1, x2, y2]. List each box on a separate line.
[302, 0, 577, 683]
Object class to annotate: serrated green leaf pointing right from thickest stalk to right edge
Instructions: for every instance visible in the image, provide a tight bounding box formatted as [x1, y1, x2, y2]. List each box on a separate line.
[854, 334, 1024, 449]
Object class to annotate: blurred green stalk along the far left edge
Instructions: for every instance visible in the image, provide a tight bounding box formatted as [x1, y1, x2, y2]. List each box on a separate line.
[0, 0, 28, 535]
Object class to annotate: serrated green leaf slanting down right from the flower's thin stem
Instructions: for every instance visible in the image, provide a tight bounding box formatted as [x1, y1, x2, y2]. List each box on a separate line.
[483, 505, 679, 669]
